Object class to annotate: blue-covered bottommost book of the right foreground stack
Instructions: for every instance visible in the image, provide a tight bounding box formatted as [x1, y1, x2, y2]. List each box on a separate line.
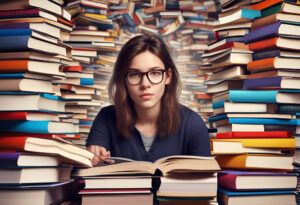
[218, 189, 297, 205]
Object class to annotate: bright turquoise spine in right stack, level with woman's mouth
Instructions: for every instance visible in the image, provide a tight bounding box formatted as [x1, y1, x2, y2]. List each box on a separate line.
[229, 90, 278, 103]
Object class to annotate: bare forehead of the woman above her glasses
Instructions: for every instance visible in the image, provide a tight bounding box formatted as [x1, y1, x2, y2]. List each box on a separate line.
[130, 51, 164, 71]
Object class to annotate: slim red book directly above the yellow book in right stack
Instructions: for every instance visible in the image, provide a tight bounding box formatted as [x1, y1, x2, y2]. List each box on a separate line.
[216, 131, 292, 139]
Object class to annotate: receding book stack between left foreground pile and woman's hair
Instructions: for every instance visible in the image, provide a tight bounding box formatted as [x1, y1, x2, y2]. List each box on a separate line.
[63, 0, 119, 146]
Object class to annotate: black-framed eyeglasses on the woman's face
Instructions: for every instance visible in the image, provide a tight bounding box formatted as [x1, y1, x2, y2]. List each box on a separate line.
[126, 69, 167, 85]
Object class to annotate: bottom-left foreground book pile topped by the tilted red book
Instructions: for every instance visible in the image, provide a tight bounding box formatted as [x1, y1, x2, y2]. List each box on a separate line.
[0, 136, 93, 205]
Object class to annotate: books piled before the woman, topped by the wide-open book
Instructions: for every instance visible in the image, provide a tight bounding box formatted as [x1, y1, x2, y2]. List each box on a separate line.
[74, 156, 219, 205]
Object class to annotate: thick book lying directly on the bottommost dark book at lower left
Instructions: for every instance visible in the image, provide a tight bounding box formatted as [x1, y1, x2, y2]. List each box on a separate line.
[0, 166, 72, 184]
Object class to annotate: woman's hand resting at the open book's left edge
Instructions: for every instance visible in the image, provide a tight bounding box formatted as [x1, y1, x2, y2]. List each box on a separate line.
[87, 145, 114, 166]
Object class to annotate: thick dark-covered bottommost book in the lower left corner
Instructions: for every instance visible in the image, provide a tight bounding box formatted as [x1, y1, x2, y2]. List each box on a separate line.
[0, 179, 84, 205]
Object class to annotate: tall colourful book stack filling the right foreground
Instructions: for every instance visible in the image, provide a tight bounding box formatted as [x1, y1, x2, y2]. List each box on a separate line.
[207, 0, 300, 204]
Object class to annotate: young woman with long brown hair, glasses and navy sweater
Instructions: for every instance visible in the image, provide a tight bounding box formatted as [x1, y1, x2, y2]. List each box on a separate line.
[87, 35, 210, 164]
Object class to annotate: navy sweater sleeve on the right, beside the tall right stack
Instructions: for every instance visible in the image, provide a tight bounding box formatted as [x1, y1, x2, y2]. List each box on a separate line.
[186, 111, 210, 156]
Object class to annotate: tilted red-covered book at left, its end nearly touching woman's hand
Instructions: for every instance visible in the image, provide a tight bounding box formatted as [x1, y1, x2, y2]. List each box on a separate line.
[0, 136, 94, 167]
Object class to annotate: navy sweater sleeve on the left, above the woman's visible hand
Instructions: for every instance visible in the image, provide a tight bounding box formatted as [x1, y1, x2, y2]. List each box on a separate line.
[86, 108, 112, 150]
